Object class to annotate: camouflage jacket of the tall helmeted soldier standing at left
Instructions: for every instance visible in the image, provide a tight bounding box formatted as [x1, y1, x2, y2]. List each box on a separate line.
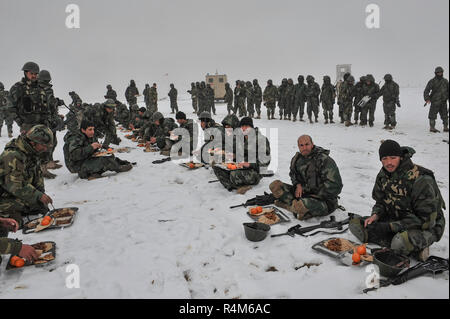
[9, 78, 51, 126]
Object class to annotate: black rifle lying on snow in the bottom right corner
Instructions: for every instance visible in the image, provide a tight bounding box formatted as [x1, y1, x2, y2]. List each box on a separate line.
[363, 256, 448, 293]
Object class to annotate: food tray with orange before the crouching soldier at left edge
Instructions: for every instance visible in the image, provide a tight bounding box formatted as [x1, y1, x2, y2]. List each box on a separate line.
[22, 207, 78, 234]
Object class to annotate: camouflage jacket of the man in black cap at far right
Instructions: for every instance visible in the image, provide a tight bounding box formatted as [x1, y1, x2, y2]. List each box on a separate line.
[372, 147, 445, 238]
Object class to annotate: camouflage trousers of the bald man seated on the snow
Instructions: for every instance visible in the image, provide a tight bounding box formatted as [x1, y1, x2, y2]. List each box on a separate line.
[269, 180, 330, 219]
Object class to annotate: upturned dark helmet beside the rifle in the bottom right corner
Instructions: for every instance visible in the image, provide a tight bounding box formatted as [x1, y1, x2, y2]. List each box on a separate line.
[373, 248, 409, 277]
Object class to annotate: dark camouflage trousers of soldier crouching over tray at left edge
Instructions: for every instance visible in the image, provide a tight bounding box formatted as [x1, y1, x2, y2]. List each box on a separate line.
[0, 197, 48, 228]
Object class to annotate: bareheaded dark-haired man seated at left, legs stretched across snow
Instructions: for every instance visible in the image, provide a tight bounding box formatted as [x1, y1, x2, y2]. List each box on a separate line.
[63, 120, 133, 179]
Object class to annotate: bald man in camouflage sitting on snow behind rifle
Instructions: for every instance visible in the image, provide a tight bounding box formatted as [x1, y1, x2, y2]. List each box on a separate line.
[269, 135, 343, 220]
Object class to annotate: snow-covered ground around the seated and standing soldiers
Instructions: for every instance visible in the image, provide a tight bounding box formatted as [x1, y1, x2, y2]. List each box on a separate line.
[0, 89, 449, 299]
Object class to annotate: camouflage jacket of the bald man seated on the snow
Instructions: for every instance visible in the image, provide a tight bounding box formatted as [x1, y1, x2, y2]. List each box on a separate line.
[289, 146, 343, 212]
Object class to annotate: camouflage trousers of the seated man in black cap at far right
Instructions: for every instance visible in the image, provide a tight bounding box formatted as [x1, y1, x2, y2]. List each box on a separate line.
[355, 216, 441, 256]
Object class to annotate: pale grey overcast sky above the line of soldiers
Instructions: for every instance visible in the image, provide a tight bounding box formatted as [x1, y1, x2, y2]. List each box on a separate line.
[0, 0, 449, 104]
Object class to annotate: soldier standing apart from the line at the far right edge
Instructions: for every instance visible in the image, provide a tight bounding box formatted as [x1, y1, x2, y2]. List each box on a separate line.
[423, 66, 449, 133]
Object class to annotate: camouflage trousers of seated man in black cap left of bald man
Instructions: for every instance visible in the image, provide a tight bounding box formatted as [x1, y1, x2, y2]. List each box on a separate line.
[213, 166, 262, 191]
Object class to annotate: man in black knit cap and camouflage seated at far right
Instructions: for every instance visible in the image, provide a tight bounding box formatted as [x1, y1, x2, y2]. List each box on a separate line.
[349, 140, 445, 260]
